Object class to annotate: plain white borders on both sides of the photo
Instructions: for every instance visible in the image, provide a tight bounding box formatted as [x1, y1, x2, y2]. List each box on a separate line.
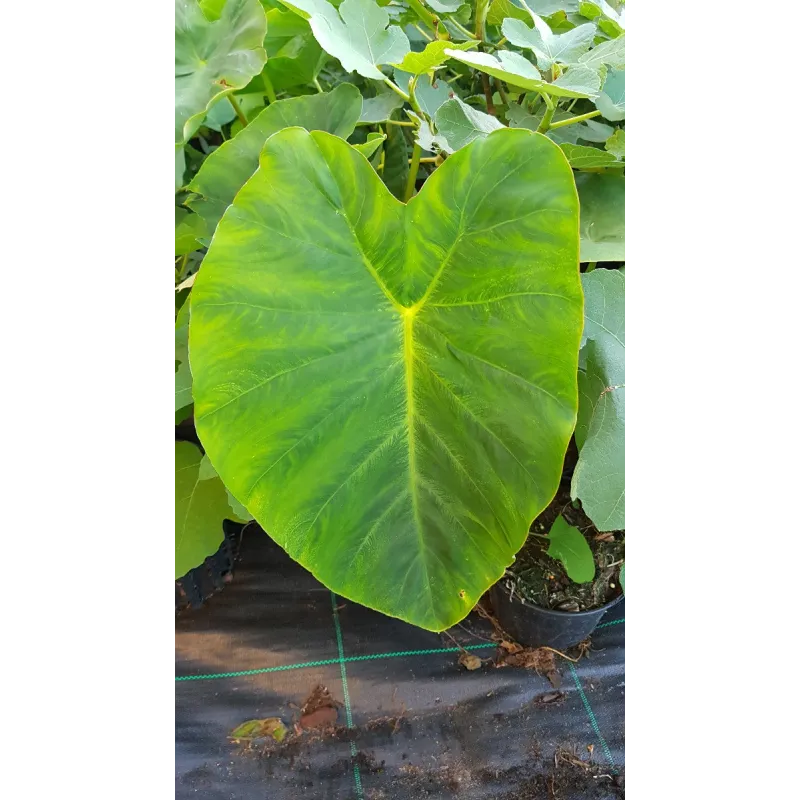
[0, 0, 800, 800]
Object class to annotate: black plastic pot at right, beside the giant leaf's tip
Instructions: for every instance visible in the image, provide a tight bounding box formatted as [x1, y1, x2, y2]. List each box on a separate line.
[489, 583, 624, 650]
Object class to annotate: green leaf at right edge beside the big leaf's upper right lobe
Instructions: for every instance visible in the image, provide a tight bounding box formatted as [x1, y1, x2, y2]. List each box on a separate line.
[575, 172, 628, 261]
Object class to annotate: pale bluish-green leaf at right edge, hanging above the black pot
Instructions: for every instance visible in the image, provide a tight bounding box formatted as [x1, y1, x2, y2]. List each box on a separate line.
[572, 269, 627, 531]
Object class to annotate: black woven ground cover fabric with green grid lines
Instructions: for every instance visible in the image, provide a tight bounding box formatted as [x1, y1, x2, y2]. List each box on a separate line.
[170, 526, 627, 800]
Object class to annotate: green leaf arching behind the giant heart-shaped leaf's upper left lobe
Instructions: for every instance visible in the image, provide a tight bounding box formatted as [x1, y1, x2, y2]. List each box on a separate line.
[187, 83, 361, 231]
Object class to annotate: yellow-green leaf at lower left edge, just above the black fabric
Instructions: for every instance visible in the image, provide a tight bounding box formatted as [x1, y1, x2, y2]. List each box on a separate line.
[172, 442, 230, 578]
